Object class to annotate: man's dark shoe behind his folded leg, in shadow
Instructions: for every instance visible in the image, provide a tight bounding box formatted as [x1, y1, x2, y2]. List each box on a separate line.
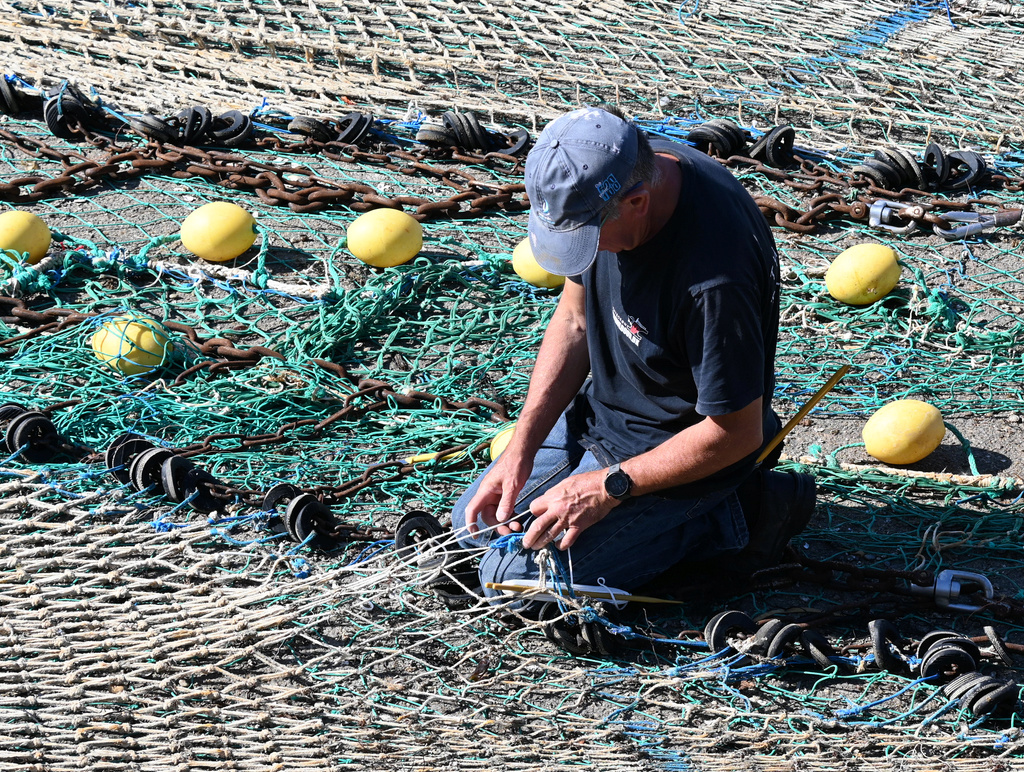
[736, 468, 816, 571]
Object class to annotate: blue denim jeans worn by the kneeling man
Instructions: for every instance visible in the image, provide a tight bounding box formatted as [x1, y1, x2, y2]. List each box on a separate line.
[452, 397, 749, 595]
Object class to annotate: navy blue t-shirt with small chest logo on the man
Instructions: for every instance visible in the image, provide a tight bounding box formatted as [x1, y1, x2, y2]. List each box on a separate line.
[573, 140, 778, 487]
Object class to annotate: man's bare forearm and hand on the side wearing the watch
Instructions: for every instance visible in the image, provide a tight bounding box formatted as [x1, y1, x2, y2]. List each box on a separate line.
[523, 397, 763, 550]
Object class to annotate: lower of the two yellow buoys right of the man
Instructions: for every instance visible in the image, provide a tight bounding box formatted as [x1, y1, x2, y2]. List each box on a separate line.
[860, 399, 946, 464]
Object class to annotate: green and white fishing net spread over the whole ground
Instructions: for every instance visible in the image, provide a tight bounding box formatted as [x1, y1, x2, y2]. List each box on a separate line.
[0, 0, 1024, 771]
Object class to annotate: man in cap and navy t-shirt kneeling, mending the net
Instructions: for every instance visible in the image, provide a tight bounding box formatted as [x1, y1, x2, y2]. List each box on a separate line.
[453, 108, 814, 594]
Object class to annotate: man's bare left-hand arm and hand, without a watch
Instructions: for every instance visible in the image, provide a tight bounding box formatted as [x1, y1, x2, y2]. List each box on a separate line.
[466, 282, 590, 534]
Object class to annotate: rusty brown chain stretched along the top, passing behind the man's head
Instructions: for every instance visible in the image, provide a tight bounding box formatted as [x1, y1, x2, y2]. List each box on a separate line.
[0, 120, 1024, 233]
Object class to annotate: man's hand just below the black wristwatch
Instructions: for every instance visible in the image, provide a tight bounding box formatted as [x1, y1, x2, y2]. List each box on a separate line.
[522, 469, 618, 550]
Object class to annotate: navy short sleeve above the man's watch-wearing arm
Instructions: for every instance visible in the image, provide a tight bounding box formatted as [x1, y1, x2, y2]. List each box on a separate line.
[682, 283, 765, 416]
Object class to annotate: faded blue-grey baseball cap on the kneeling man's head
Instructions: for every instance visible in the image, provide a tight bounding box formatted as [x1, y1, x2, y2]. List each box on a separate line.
[526, 108, 637, 276]
